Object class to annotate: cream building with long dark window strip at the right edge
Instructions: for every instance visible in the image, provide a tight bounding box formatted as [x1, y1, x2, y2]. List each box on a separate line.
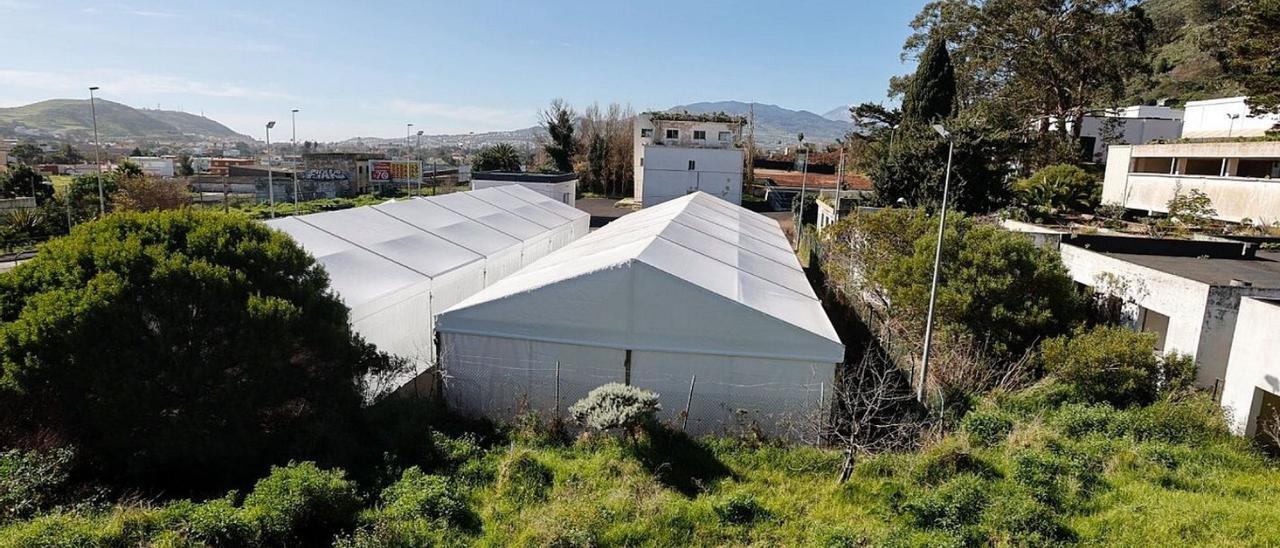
[1102, 141, 1280, 224]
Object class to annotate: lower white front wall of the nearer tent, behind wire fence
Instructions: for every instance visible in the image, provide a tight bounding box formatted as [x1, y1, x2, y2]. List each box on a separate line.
[440, 346, 832, 443]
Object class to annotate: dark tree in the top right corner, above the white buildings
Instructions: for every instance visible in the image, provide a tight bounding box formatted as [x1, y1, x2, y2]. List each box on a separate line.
[1220, 0, 1280, 113]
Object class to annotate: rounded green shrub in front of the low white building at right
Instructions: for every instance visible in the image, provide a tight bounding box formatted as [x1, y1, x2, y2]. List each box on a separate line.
[1041, 326, 1161, 407]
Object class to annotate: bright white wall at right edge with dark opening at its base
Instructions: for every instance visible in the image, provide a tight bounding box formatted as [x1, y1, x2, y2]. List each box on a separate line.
[1221, 298, 1280, 435]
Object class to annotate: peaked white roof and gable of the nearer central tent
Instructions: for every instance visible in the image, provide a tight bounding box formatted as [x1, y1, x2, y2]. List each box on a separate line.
[439, 192, 844, 361]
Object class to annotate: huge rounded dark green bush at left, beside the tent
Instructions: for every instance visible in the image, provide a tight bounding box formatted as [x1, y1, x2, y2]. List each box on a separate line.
[0, 211, 390, 492]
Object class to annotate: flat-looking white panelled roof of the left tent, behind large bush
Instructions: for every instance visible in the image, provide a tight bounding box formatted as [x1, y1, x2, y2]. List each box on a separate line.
[266, 186, 588, 315]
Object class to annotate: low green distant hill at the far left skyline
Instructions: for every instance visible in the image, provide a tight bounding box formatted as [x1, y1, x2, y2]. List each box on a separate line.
[0, 99, 252, 141]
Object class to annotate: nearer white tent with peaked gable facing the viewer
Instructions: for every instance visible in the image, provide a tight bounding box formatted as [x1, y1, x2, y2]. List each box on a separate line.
[438, 192, 844, 435]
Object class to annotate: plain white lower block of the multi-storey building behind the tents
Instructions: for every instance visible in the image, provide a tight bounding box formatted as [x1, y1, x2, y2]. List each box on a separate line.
[636, 145, 742, 207]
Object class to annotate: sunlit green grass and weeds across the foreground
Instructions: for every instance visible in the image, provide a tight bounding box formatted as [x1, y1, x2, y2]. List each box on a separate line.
[0, 386, 1280, 547]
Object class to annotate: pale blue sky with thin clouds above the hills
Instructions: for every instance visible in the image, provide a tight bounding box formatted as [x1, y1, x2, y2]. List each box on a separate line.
[0, 0, 923, 141]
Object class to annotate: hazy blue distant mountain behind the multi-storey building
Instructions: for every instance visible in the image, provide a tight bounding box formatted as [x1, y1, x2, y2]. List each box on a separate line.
[667, 101, 854, 149]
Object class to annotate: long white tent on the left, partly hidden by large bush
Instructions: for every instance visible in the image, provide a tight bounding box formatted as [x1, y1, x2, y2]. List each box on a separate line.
[268, 187, 590, 388]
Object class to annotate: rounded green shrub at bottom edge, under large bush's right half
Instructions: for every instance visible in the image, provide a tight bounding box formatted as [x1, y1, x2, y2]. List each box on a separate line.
[244, 462, 360, 544]
